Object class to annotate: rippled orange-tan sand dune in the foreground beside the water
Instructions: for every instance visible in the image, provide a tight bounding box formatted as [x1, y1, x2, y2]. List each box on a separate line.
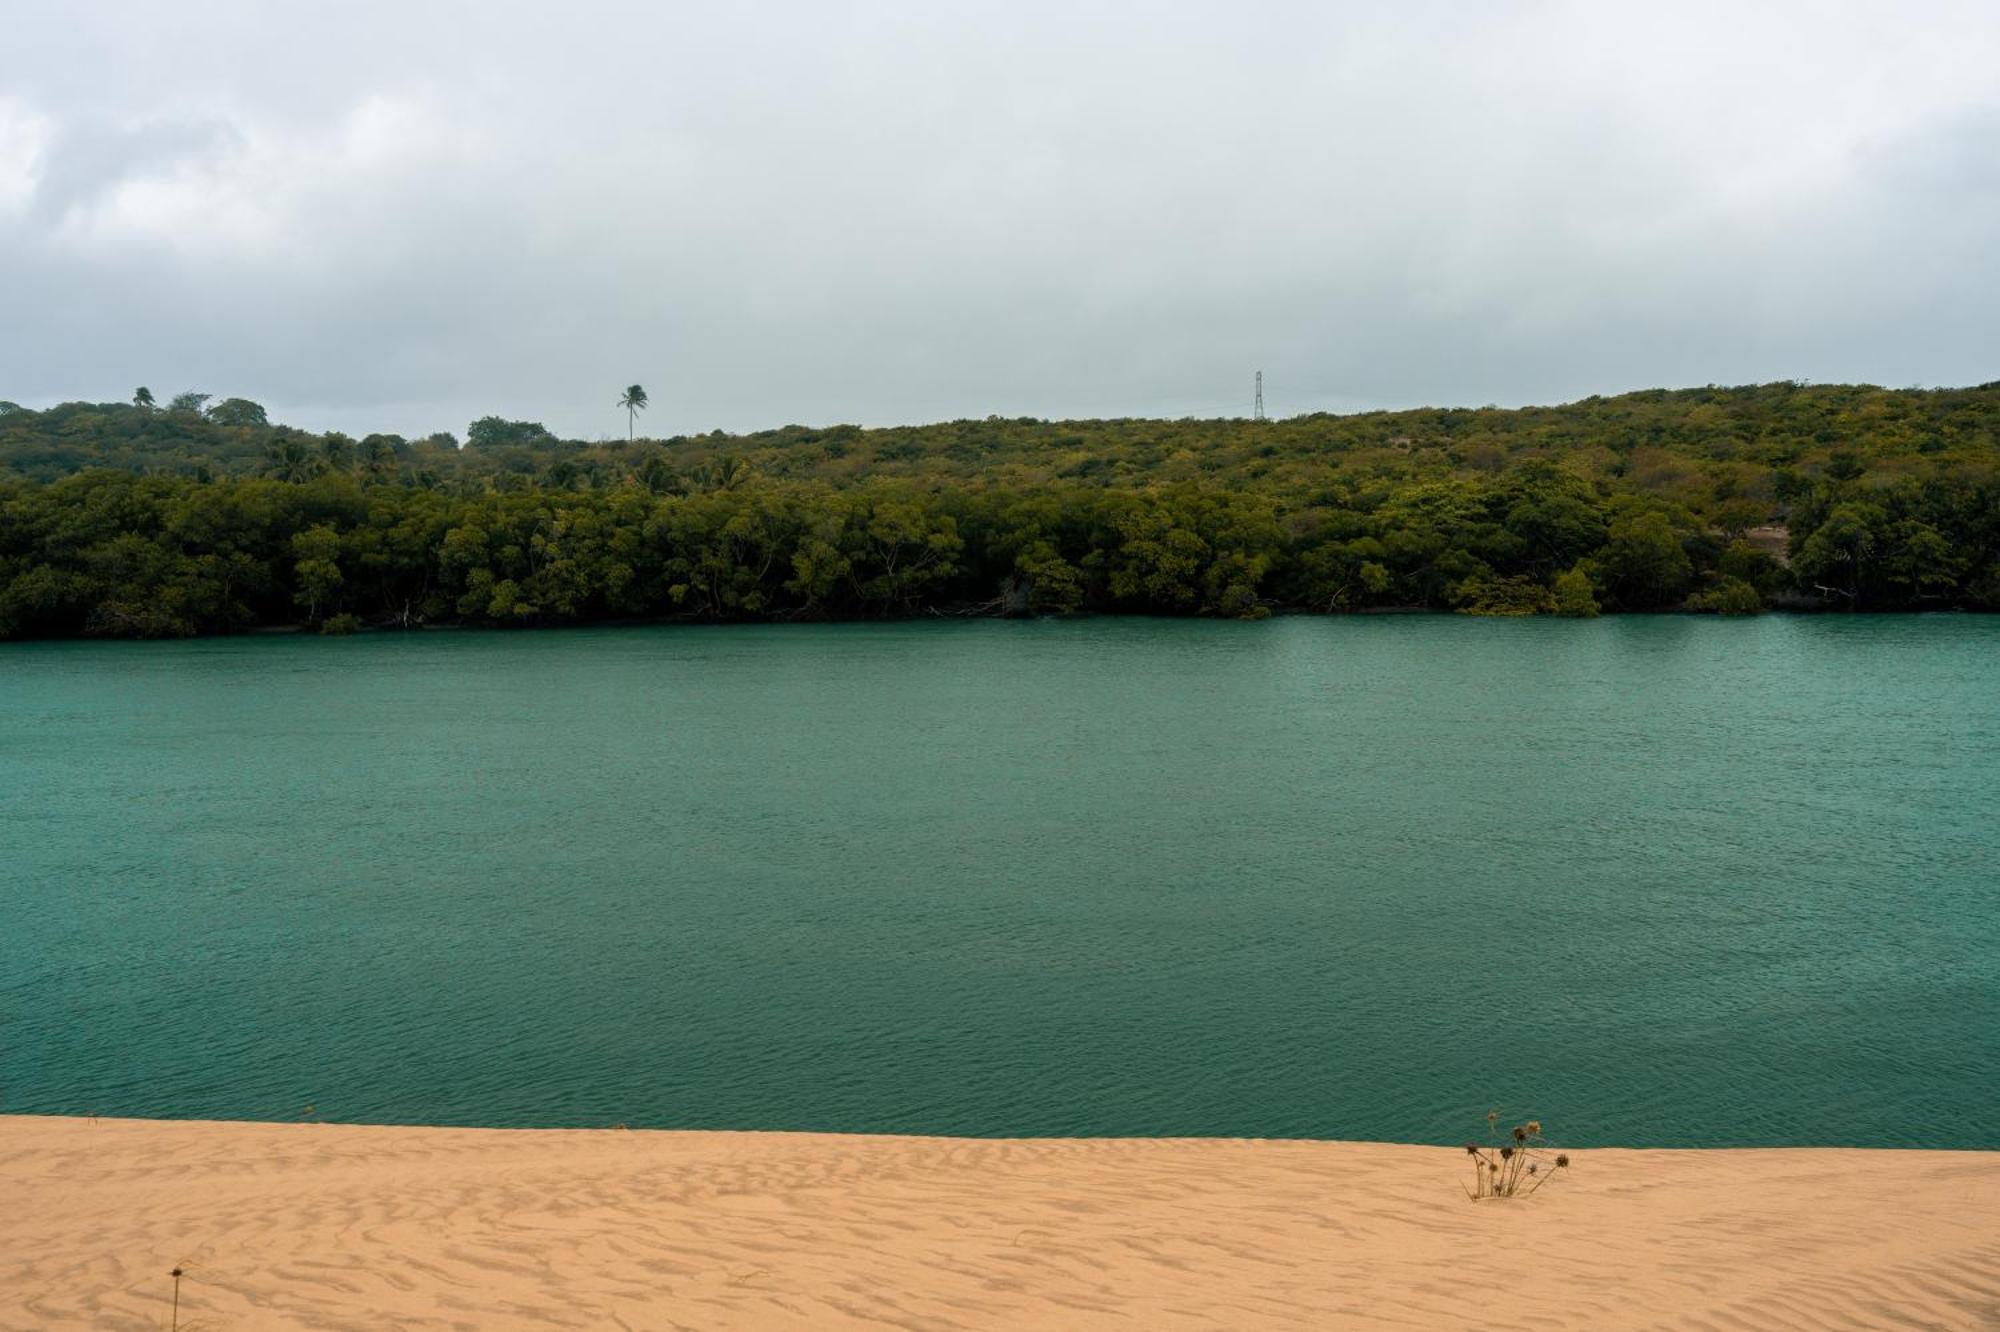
[0, 1116, 2000, 1332]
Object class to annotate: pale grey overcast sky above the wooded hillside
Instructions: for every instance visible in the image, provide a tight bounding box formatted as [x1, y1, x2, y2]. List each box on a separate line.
[0, 0, 2000, 438]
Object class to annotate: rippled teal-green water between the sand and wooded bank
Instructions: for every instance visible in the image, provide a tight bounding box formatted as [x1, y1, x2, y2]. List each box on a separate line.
[0, 616, 2000, 1148]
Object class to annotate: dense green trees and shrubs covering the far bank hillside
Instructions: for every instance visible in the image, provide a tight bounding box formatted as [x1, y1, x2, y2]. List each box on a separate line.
[0, 382, 2000, 638]
